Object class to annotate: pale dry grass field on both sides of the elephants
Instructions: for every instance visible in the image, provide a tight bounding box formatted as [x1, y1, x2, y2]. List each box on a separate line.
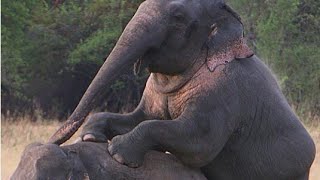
[1, 116, 320, 180]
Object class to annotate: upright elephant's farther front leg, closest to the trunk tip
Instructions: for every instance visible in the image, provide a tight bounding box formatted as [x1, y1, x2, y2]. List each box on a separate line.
[78, 108, 144, 142]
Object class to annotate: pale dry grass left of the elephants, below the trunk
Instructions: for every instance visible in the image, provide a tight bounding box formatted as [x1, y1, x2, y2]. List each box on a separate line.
[1, 118, 77, 180]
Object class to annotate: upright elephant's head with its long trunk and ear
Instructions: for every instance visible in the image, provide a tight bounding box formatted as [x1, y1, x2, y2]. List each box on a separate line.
[49, 0, 251, 144]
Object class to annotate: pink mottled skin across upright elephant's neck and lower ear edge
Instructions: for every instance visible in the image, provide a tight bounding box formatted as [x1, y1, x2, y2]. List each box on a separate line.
[144, 38, 253, 119]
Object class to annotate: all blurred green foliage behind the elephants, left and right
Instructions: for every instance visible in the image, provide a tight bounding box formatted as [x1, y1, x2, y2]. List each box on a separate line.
[1, 0, 320, 121]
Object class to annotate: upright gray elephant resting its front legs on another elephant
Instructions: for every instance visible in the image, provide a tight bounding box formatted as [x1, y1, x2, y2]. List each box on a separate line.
[49, 0, 315, 180]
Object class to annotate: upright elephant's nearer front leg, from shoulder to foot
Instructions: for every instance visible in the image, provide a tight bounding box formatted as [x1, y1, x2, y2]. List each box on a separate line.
[108, 93, 239, 167]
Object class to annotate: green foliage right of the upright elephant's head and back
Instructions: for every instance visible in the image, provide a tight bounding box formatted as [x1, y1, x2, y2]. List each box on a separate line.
[229, 0, 320, 119]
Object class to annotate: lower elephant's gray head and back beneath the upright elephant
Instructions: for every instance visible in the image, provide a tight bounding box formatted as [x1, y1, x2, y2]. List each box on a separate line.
[10, 142, 206, 180]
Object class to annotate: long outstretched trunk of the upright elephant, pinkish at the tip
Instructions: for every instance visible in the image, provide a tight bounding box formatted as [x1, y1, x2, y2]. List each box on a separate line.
[49, 4, 165, 144]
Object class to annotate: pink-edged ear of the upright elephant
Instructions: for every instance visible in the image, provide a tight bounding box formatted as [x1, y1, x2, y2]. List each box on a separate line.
[206, 4, 254, 72]
